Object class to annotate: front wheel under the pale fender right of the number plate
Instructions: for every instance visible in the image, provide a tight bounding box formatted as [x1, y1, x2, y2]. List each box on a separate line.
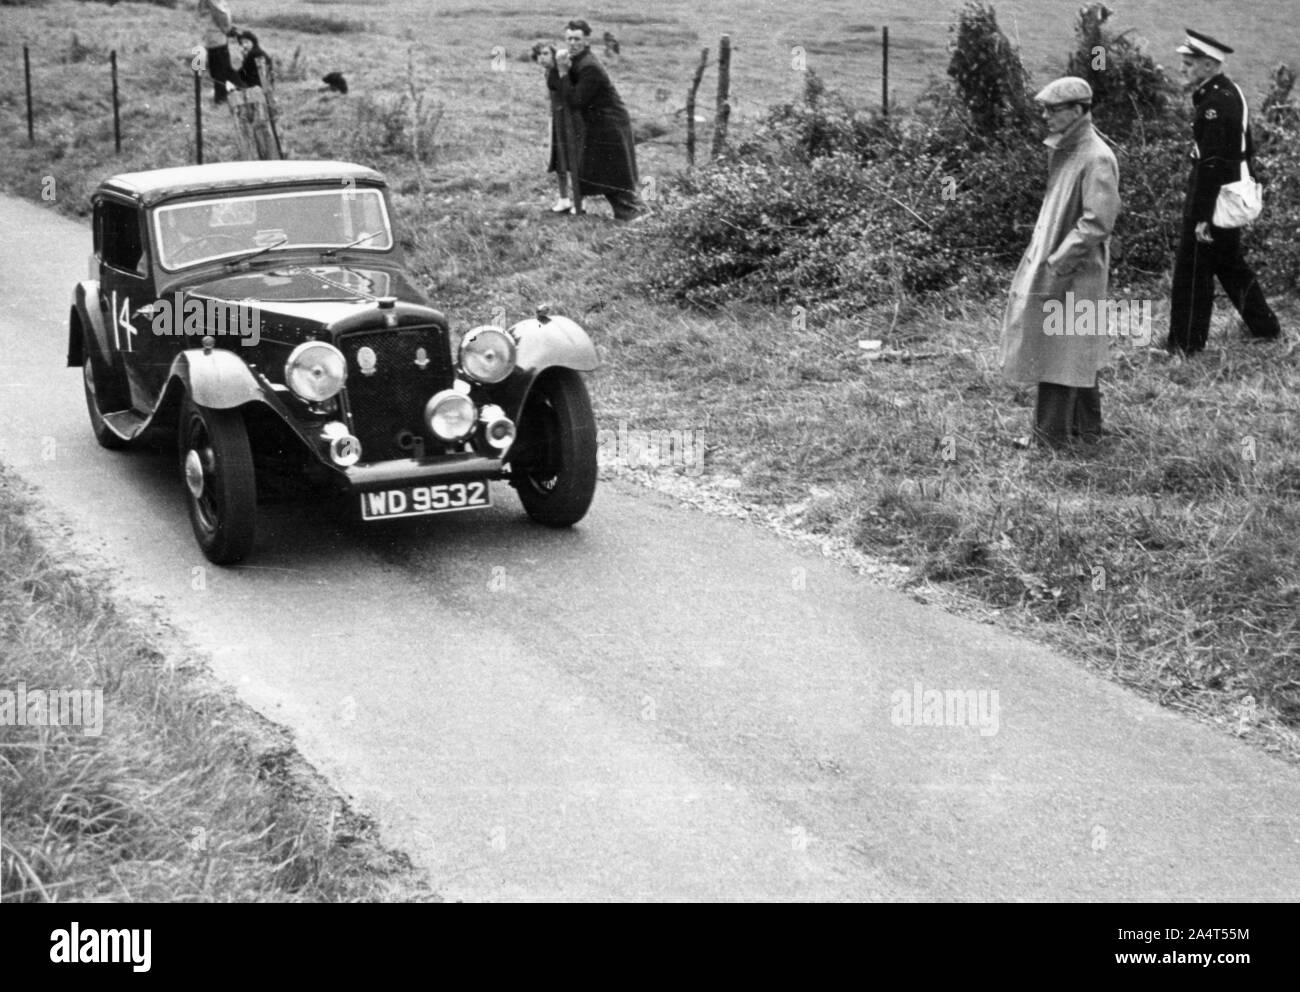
[510, 368, 595, 527]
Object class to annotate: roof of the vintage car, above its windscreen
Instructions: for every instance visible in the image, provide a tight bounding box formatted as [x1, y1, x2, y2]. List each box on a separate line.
[99, 161, 384, 207]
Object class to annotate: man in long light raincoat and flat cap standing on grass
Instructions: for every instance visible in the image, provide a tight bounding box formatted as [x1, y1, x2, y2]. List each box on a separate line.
[1002, 75, 1119, 447]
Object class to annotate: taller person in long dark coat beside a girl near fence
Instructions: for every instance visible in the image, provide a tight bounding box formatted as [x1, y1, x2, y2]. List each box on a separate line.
[556, 21, 645, 221]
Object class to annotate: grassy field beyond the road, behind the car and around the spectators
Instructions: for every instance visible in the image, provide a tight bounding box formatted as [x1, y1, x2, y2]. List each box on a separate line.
[0, 0, 1300, 892]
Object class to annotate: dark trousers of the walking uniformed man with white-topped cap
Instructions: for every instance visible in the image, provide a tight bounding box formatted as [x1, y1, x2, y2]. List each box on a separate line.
[1167, 217, 1282, 355]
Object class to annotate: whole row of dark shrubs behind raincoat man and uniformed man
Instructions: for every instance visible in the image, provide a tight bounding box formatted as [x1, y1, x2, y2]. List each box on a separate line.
[638, 4, 1300, 313]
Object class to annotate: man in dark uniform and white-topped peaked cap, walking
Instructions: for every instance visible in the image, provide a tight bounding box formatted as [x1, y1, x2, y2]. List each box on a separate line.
[1167, 29, 1282, 355]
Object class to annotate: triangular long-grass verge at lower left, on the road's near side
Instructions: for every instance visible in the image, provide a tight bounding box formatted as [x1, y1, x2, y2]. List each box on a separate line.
[0, 467, 436, 902]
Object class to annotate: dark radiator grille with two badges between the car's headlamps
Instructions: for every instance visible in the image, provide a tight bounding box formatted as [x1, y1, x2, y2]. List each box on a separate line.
[338, 326, 454, 464]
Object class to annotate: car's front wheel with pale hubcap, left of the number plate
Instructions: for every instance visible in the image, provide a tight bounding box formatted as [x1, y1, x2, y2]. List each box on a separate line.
[177, 397, 257, 564]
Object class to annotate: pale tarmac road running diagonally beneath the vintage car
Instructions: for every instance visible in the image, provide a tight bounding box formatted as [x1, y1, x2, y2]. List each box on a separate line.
[0, 198, 1300, 901]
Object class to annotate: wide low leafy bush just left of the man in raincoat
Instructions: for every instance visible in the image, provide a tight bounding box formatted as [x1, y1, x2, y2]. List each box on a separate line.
[642, 77, 1044, 313]
